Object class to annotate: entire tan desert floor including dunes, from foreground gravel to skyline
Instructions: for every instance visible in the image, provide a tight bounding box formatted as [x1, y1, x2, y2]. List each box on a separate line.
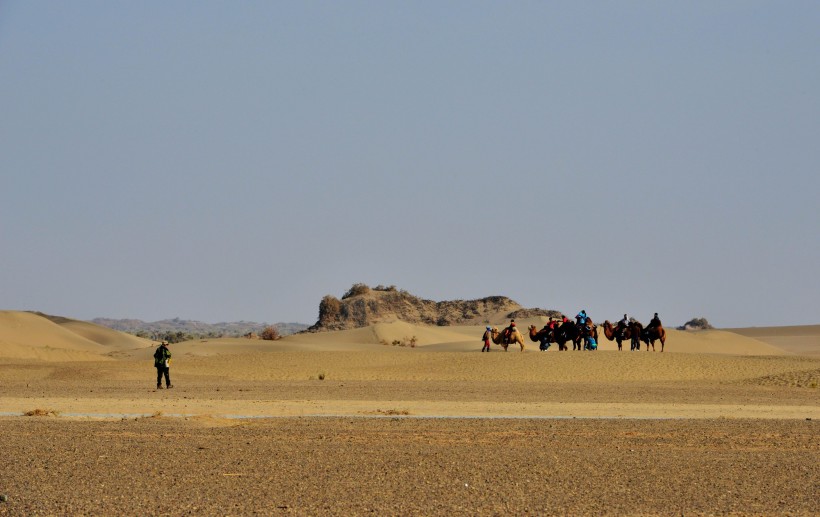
[0, 311, 820, 515]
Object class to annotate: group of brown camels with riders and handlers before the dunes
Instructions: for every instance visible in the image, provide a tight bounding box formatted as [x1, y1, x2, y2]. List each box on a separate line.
[488, 311, 666, 352]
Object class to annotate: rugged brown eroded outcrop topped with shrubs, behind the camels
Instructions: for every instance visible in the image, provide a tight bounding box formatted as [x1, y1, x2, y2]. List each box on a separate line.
[308, 284, 561, 332]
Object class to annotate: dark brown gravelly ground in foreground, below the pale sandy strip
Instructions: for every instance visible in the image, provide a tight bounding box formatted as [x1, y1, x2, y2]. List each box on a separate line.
[0, 417, 820, 515]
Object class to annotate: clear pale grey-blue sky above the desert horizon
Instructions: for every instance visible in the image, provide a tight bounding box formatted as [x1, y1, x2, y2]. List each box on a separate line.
[0, 0, 820, 326]
